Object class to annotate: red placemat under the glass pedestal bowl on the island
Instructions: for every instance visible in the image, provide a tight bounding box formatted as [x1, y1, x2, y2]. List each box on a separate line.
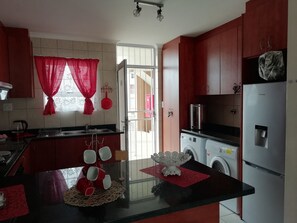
[140, 165, 209, 187]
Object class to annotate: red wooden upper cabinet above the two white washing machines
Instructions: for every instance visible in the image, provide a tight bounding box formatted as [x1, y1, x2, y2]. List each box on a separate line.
[195, 17, 242, 95]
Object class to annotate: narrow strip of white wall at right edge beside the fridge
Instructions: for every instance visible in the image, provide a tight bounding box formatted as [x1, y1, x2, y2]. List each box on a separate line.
[284, 0, 297, 223]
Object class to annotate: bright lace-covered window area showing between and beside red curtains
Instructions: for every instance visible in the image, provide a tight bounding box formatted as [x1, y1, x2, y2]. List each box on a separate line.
[43, 64, 100, 112]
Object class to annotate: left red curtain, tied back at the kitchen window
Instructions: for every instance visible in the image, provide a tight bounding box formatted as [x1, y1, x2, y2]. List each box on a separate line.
[34, 56, 66, 115]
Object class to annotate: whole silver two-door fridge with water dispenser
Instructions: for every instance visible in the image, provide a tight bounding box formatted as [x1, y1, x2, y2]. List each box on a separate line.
[242, 82, 286, 223]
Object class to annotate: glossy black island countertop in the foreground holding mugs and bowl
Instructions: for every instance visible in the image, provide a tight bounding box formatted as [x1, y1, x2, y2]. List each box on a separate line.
[0, 159, 254, 223]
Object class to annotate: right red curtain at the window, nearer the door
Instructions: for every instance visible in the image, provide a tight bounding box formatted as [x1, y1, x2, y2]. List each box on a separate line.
[67, 58, 99, 115]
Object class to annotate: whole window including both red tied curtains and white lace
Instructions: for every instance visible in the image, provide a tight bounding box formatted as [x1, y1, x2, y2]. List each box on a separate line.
[34, 56, 99, 115]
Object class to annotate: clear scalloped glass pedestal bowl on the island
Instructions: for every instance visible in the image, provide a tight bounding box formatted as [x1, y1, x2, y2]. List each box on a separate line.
[151, 151, 191, 177]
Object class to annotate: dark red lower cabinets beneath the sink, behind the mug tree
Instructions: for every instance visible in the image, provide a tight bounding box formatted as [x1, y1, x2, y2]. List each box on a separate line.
[27, 135, 120, 173]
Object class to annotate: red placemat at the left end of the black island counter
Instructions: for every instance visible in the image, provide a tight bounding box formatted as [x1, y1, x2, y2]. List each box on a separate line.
[0, 184, 29, 221]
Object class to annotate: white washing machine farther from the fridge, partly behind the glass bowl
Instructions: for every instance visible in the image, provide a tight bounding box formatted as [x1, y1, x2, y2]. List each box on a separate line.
[180, 132, 207, 165]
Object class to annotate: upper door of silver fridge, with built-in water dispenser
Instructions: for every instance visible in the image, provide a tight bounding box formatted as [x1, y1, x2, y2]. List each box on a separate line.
[243, 82, 286, 174]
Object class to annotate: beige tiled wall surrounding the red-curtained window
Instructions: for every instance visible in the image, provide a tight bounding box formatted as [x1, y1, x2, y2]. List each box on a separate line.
[0, 38, 117, 130]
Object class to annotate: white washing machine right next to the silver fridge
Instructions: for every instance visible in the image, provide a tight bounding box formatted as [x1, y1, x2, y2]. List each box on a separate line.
[205, 139, 239, 214]
